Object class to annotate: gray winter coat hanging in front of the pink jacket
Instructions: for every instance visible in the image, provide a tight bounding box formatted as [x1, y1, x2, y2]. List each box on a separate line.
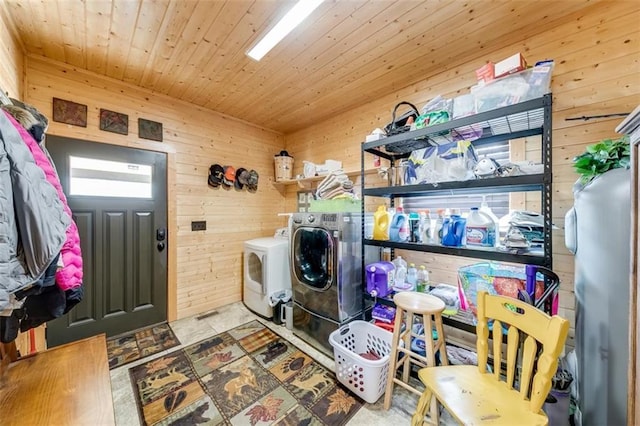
[0, 111, 71, 310]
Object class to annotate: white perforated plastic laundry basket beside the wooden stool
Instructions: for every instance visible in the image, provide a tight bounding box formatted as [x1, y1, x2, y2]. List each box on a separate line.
[329, 321, 393, 404]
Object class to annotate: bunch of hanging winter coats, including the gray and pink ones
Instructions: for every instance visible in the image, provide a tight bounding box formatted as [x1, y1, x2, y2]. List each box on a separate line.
[0, 100, 83, 343]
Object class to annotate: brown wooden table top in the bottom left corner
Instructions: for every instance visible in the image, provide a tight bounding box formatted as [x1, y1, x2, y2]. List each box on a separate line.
[0, 334, 115, 426]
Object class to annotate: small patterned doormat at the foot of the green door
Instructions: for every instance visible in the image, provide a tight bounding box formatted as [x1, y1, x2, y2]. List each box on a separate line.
[107, 323, 180, 370]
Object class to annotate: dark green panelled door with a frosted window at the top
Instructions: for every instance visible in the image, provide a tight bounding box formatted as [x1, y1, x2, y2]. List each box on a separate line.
[46, 135, 169, 347]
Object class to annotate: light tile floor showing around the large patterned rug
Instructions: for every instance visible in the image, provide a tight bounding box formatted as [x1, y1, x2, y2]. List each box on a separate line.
[111, 302, 418, 426]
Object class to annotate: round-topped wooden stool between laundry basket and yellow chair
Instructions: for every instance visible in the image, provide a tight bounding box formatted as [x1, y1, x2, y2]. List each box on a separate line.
[384, 291, 449, 424]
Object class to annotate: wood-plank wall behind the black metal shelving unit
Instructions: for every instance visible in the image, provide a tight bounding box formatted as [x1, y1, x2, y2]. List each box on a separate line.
[285, 1, 640, 345]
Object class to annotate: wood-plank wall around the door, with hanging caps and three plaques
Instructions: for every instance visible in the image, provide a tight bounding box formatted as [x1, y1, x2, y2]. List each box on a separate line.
[25, 56, 286, 319]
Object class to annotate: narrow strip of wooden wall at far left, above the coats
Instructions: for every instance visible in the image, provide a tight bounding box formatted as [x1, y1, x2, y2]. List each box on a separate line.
[0, 2, 24, 98]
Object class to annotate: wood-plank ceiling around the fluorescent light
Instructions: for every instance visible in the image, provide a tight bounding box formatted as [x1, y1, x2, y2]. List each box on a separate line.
[3, 0, 594, 134]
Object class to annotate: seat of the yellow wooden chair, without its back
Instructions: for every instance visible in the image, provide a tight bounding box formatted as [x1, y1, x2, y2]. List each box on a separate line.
[418, 365, 548, 426]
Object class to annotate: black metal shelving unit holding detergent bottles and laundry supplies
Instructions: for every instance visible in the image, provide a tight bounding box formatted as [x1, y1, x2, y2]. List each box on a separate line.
[361, 94, 557, 331]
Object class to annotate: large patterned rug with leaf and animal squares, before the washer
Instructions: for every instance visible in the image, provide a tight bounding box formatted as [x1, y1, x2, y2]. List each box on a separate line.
[129, 321, 363, 425]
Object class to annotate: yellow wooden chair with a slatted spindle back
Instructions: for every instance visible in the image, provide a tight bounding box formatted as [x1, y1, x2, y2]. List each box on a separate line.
[411, 291, 569, 426]
